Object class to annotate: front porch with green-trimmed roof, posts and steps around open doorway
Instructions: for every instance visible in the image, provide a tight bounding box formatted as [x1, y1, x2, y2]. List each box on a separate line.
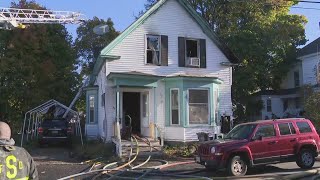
[108, 72, 163, 157]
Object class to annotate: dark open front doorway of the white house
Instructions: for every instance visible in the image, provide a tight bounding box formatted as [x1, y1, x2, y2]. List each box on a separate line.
[122, 92, 141, 135]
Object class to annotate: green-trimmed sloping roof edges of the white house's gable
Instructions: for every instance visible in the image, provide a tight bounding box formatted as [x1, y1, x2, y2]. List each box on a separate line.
[91, 0, 240, 83]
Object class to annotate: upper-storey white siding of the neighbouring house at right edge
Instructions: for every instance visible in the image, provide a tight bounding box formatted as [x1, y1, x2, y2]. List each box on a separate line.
[301, 54, 320, 85]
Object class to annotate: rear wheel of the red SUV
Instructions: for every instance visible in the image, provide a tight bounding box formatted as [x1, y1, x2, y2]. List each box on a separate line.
[296, 149, 316, 169]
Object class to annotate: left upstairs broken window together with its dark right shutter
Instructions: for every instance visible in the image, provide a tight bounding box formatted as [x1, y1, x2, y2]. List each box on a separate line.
[146, 35, 168, 66]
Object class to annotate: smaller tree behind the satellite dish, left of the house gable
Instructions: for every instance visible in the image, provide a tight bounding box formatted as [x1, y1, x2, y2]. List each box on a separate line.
[74, 17, 119, 75]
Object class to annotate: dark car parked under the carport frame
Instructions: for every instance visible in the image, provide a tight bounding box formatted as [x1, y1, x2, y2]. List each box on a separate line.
[38, 119, 72, 145]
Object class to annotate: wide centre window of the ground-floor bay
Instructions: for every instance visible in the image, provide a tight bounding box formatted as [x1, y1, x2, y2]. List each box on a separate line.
[189, 89, 209, 124]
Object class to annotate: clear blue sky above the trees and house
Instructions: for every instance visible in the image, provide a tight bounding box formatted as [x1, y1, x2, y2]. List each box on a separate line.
[0, 0, 320, 44]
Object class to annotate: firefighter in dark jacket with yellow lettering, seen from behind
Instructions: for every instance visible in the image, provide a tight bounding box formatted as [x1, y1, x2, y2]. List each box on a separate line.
[0, 121, 39, 180]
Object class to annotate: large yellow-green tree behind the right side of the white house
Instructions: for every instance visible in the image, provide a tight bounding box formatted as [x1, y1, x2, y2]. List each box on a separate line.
[146, 0, 307, 119]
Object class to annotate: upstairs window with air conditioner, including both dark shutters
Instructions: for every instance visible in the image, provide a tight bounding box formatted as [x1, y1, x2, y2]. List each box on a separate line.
[178, 37, 207, 68]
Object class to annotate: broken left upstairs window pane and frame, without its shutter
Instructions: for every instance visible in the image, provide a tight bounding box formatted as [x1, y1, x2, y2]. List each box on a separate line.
[146, 35, 161, 65]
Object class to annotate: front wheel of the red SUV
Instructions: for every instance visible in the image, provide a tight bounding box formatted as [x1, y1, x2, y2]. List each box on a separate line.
[227, 156, 248, 176]
